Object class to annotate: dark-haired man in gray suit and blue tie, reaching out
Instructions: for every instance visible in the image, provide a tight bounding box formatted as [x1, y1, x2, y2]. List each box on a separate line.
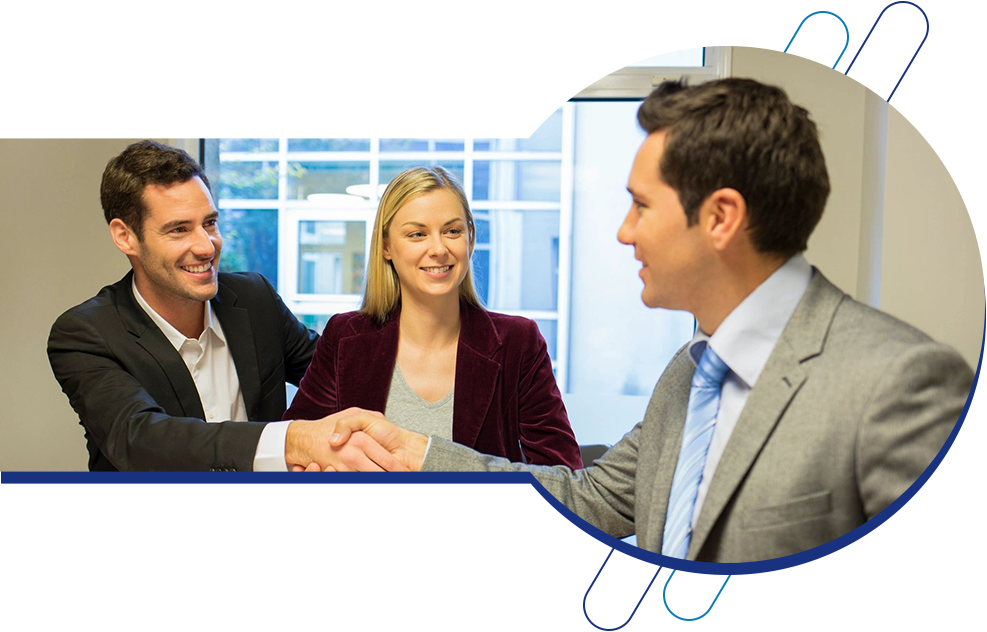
[318, 79, 973, 562]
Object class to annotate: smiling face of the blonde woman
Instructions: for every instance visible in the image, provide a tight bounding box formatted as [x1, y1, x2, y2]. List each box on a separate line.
[383, 189, 470, 300]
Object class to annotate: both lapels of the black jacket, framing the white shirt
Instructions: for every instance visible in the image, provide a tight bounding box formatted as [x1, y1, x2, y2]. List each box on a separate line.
[114, 270, 261, 419]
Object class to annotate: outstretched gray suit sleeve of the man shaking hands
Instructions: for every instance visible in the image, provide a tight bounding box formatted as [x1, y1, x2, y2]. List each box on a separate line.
[422, 424, 641, 538]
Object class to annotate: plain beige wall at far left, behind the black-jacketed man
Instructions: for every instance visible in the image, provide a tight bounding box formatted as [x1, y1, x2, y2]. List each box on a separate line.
[0, 138, 167, 470]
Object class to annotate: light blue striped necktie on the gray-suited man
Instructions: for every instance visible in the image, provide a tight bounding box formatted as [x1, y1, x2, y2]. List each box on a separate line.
[661, 343, 730, 559]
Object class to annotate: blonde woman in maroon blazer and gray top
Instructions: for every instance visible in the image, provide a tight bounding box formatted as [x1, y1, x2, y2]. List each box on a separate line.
[284, 167, 582, 469]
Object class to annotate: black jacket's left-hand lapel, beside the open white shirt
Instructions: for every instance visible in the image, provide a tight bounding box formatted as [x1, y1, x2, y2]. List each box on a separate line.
[117, 271, 205, 419]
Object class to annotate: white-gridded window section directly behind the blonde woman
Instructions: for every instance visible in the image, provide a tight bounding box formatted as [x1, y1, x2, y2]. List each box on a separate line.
[204, 116, 574, 384]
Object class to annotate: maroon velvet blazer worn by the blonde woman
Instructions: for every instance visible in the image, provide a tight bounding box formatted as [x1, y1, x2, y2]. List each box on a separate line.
[284, 303, 583, 469]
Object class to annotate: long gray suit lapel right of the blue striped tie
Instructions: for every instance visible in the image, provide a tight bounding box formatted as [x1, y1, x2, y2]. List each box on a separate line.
[688, 270, 845, 560]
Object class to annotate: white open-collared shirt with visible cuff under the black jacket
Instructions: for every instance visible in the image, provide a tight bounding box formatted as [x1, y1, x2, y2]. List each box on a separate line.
[131, 281, 288, 472]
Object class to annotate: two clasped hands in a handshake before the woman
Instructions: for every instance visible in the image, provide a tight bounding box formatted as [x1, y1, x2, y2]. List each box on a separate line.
[284, 408, 428, 472]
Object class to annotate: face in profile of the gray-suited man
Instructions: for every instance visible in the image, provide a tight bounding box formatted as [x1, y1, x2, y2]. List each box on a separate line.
[617, 132, 706, 313]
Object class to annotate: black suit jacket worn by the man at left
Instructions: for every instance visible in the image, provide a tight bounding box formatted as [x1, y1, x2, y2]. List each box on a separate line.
[48, 272, 318, 471]
